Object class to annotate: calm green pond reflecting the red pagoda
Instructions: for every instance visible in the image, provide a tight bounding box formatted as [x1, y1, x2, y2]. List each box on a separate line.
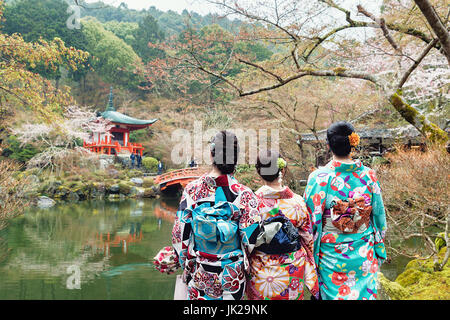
[0, 199, 407, 300]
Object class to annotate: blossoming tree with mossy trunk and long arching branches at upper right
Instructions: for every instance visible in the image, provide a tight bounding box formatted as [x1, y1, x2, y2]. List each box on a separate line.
[146, 0, 450, 142]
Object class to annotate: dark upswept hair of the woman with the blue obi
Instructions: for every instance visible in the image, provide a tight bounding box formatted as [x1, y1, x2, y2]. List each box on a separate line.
[211, 131, 239, 174]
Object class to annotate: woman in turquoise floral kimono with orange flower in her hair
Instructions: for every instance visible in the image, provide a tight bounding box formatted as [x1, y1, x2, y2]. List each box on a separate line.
[304, 121, 386, 300]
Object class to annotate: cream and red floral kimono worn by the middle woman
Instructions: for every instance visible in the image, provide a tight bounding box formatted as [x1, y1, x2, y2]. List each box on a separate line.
[247, 186, 319, 300]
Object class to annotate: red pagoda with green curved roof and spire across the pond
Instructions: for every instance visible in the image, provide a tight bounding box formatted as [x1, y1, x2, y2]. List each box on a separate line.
[83, 88, 158, 156]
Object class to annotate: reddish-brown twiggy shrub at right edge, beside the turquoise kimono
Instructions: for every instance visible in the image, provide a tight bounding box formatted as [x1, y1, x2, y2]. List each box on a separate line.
[375, 146, 450, 269]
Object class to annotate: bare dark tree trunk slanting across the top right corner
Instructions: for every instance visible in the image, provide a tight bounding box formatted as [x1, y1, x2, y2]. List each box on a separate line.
[414, 0, 450, 64]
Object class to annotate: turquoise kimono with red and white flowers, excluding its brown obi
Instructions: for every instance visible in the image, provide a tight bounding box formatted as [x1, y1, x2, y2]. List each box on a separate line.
[304, 160, 386, 300]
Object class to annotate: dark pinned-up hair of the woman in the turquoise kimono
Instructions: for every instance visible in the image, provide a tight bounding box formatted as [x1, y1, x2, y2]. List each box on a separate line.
[327, 121, 355, 157]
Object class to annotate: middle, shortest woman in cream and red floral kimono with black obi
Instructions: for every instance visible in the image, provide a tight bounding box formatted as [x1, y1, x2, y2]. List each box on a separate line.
[247, 150, 319, 300]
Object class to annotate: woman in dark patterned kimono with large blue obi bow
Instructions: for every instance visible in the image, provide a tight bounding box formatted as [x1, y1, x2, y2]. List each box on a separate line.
[172, 131, 261, 300]
